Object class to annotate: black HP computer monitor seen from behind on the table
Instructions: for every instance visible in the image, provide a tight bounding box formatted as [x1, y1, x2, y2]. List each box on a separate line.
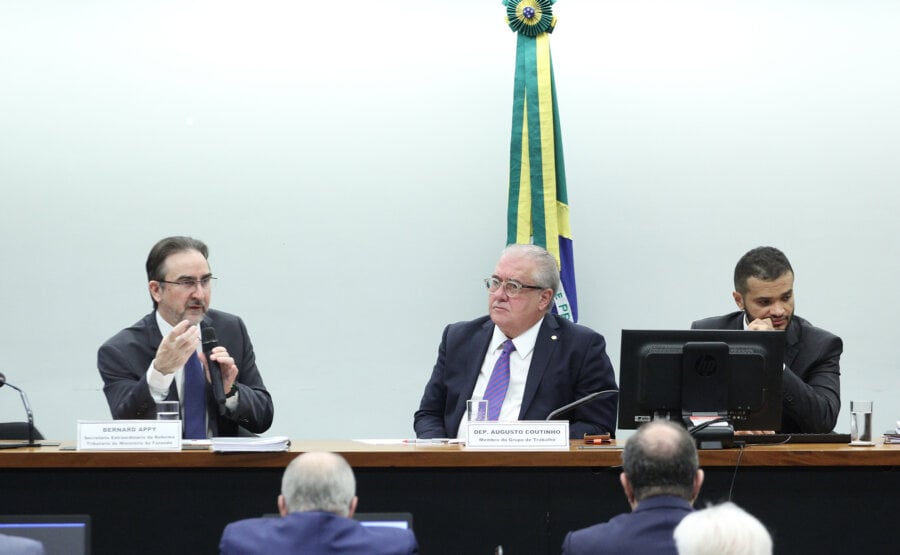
[619, 330, 785, 444]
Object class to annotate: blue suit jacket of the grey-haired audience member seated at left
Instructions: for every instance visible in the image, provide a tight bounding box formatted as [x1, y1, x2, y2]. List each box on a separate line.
[219, 511, 419, 555]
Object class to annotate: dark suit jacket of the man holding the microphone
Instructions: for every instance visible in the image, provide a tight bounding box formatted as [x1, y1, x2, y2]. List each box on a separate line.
[97, 310, 273, 436]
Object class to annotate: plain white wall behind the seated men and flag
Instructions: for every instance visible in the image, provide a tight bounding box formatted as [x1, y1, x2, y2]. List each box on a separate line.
[0, 0, 900, 439]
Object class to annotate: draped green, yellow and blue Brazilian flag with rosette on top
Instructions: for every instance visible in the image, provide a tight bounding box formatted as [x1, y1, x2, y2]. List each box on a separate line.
[503, 0, 578, 322]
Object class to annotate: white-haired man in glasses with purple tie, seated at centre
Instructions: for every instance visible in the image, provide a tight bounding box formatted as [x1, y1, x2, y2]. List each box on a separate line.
[414, 245, 616, 439]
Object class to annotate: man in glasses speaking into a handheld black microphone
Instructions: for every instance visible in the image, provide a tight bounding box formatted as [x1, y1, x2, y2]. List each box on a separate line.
[97, 237, 273, 439]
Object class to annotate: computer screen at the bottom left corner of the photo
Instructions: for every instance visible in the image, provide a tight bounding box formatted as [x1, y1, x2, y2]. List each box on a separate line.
[0, 515, 91, 555]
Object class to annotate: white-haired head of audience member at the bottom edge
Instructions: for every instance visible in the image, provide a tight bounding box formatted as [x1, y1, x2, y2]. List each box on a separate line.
[675, 502, 772, 555]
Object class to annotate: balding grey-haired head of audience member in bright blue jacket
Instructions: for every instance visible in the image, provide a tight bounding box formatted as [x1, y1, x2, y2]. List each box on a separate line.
[278, 452, 357, 517]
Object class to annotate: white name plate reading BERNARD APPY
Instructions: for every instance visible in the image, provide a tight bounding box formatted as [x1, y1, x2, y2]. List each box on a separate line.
[75, 420, 181, 451]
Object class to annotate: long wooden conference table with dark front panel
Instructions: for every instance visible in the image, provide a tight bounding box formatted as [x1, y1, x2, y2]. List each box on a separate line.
[0, 440, 900, 555]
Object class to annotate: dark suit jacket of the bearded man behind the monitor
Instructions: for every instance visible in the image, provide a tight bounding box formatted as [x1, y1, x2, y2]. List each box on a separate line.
[691, 312, 844, 433]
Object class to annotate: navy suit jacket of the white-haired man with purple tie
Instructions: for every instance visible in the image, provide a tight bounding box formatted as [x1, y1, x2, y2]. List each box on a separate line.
[414, 314, 617, 439]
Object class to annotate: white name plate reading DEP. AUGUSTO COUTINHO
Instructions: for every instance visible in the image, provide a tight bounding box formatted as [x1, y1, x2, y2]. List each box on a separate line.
[466, 420, 569, 450]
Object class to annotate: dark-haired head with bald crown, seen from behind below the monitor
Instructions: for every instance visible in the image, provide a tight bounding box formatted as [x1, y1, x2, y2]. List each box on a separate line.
[619, 421, 703, 508]
